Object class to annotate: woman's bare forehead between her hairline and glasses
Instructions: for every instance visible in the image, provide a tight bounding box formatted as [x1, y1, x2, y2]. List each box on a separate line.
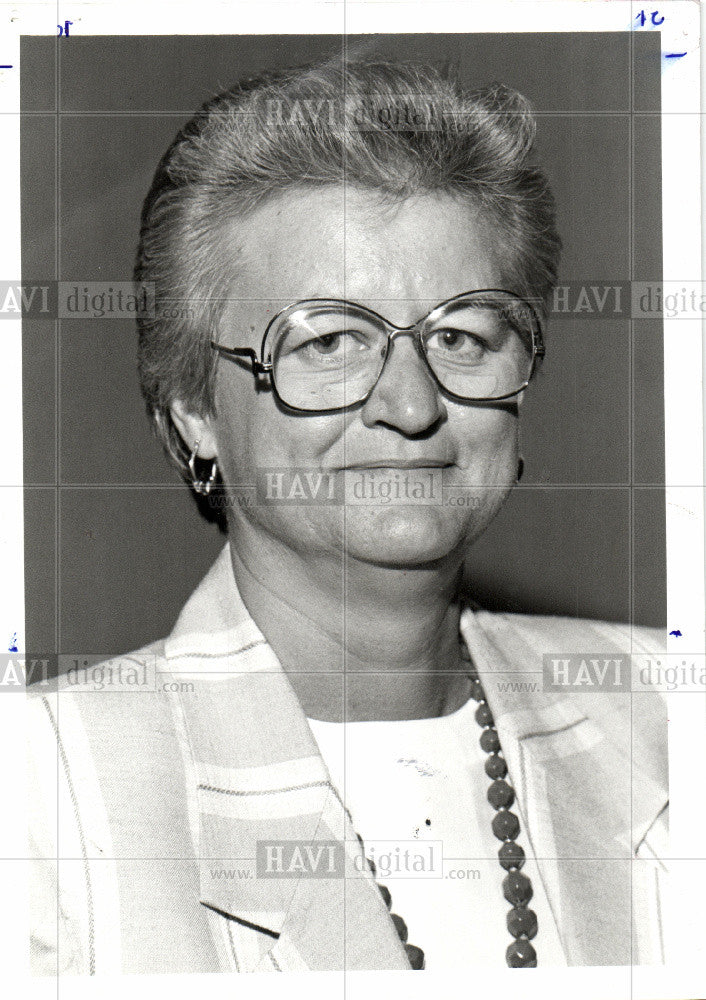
[222, 187, 500, 311]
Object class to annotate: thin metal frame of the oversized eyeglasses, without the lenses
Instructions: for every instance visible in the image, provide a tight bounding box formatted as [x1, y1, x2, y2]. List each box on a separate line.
[210, 288, 546, 414]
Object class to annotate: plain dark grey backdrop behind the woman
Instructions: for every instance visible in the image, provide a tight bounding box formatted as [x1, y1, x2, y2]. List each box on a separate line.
[21, 33, 672, 656]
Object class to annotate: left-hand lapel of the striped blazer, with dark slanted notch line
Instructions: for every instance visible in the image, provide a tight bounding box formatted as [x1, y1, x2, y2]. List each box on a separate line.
[165, 546, 409, 970]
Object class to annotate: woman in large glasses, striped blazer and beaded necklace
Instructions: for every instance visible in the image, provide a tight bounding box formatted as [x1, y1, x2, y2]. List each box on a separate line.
[32, 61, 666, 973]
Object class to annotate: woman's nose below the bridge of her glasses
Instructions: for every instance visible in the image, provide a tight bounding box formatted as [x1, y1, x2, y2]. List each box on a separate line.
[361, 336, 446, 435]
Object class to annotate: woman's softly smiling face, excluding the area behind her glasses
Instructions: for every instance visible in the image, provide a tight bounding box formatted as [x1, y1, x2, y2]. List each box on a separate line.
[195, 187, 518, 567]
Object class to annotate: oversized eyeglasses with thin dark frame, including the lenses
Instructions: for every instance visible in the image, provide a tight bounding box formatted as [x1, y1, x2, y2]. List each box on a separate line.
[211, 288, 544, 413]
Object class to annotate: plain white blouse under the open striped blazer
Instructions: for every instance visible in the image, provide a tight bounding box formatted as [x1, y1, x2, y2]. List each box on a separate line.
[308, 700, 566, 969]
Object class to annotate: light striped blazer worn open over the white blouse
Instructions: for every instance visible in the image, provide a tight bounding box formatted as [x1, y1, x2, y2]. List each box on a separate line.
[28, 546, 668, 975]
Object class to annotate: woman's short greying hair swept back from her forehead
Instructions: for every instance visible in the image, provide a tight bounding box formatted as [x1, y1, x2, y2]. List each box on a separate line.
[135, 59, 560, 478]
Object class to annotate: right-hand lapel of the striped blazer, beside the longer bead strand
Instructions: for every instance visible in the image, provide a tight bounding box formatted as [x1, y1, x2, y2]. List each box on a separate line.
[462, 612, 666, 965]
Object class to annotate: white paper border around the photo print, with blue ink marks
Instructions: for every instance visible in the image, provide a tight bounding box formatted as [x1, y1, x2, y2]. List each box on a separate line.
[0, 0, 706, 1000]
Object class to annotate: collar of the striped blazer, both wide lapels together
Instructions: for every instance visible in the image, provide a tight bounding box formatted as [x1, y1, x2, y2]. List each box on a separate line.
[165, 545, 665, 970]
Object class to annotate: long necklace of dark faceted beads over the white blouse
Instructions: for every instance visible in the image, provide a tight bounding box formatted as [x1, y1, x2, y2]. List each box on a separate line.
[356, 638, 537, 969]
